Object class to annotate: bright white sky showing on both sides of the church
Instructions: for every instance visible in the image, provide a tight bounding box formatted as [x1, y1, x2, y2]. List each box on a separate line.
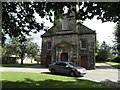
[31, 14, 116, 48]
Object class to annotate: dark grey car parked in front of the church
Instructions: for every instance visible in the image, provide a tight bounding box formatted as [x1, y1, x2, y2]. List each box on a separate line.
[49, 61, 86, 76]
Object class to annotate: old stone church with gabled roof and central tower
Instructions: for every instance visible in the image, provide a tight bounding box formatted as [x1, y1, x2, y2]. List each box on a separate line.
[41, 13, 96, 69]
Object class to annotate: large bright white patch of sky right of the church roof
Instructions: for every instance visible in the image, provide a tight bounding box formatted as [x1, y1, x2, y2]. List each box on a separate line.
[84, 18, 116, 45]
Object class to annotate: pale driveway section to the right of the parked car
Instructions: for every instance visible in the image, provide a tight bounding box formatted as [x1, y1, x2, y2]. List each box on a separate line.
[80, 63, 120, 88]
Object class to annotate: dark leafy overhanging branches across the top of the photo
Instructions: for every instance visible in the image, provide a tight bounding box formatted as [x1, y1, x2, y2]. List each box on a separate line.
[2, 2, 120, 42]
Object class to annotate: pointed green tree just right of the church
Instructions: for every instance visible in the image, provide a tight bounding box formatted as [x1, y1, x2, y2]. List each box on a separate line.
[97, 41, 111, 61]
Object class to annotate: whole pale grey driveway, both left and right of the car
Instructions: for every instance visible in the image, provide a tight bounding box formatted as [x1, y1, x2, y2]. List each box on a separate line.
[0, 63, 120, 88]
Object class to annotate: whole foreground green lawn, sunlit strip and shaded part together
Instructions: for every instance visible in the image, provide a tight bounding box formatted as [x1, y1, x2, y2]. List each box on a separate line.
[0, 72, 111, 88]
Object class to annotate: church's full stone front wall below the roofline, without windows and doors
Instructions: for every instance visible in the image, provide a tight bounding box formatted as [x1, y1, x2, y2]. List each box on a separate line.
[41, 34, 96, 69]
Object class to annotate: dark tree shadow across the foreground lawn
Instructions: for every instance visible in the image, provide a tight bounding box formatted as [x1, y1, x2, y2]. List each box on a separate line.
[2, 78, 110, 88]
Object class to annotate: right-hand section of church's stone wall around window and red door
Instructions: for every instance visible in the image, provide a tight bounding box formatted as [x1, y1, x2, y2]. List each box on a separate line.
[79, 34, 96, 69]
